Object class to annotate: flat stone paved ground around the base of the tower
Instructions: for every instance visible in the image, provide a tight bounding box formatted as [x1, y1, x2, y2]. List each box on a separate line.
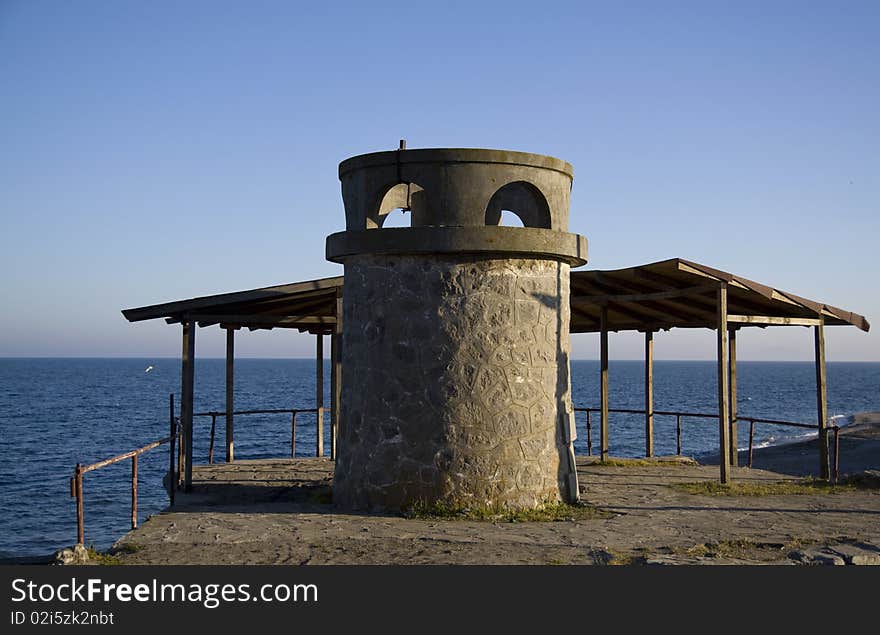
[105, 439, 880, 564]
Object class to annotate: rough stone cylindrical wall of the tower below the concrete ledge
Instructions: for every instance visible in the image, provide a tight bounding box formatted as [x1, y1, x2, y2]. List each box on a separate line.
[333, 254, 576, 509]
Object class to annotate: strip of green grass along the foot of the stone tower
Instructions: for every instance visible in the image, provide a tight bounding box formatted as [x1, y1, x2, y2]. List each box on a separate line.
[404, 502, 611, 523]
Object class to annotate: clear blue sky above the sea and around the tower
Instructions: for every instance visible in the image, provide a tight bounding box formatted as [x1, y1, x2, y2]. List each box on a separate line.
[0, 0, 880, 361]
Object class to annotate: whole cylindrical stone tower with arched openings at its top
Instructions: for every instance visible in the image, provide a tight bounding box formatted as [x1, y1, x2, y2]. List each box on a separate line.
[327, 149, 587, 509]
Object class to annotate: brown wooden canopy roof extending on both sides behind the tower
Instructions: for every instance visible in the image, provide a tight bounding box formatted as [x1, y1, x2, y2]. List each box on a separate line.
[122, 258, 870, 333]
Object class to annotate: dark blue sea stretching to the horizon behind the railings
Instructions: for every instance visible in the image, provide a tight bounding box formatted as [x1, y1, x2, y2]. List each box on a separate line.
[0, 359, 880, 557]
